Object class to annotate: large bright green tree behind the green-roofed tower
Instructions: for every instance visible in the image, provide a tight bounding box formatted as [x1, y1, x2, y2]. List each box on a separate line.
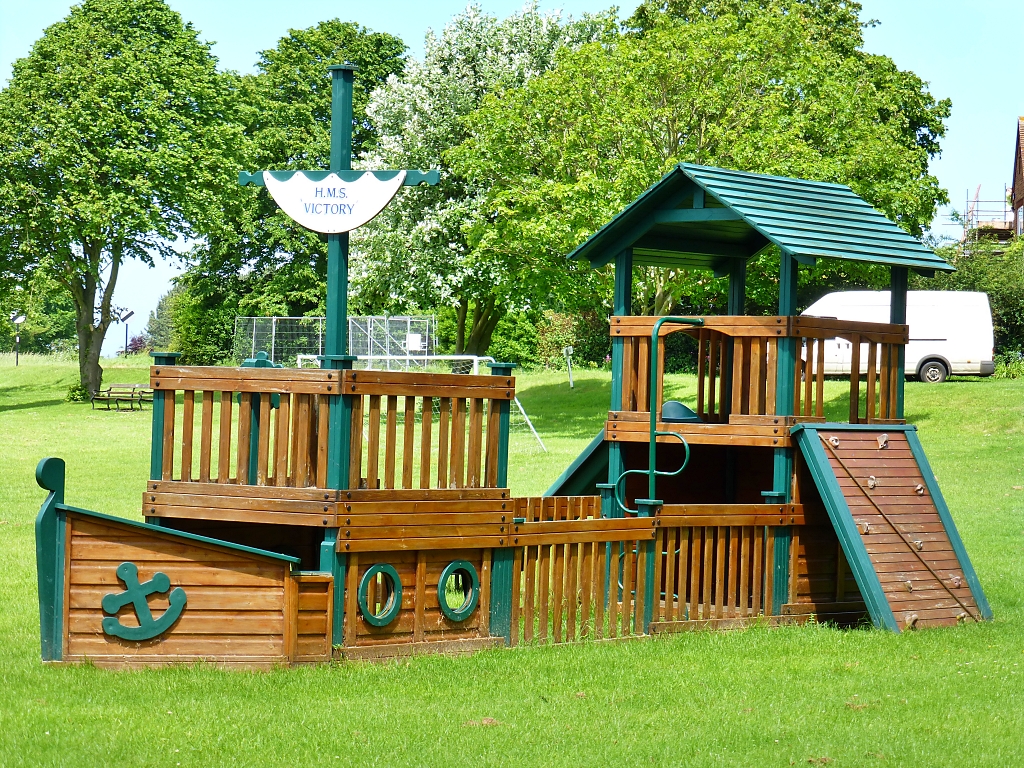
[450, 0, 950, 313]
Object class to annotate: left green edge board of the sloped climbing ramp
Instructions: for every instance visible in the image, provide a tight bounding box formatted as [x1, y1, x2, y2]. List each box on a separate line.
[796, 425, 900, 632]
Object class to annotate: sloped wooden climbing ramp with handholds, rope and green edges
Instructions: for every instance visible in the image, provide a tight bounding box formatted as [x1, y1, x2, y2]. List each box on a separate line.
[792, 424, 992, 632]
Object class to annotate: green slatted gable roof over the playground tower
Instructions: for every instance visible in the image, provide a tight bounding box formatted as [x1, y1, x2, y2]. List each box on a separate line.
[569, 163, 953, 274]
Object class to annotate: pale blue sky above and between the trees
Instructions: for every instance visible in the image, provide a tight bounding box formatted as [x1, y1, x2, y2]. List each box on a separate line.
[0, 0, 1024, 351]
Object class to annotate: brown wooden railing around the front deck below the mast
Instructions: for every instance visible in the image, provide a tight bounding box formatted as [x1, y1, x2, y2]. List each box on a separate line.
[151, 366, 515, 489]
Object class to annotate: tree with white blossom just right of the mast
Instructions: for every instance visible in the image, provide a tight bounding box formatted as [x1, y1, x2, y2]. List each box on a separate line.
[352, 3, 613, 354]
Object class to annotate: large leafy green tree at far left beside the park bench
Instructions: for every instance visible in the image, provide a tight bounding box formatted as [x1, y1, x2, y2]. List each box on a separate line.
[0, 0, 237, 391]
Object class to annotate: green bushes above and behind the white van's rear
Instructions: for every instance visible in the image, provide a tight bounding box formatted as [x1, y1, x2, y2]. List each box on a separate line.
[910, 238, 1024, 353]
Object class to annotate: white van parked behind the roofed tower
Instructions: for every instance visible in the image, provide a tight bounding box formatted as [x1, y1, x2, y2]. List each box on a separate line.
[803, 291, 995, 383]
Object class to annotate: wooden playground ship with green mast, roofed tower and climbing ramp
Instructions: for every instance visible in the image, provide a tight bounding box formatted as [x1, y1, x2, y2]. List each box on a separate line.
[37, 68, 991, 667]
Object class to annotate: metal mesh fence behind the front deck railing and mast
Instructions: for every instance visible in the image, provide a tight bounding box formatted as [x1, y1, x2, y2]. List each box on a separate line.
[232, 315, 437, 371]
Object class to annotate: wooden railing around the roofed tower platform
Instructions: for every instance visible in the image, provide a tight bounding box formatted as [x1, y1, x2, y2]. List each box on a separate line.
[611, 316, 907, 424]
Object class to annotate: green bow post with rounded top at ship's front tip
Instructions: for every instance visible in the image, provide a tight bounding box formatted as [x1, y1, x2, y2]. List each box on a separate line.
[36, 458, 65, 662]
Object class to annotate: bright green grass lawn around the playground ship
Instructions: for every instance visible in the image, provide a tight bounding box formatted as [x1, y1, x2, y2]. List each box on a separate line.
[0, 355, 1024, 768]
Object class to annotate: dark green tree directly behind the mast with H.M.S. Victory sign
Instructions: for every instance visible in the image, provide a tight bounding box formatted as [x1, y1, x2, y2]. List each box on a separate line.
[175, 19, 406, 365]
